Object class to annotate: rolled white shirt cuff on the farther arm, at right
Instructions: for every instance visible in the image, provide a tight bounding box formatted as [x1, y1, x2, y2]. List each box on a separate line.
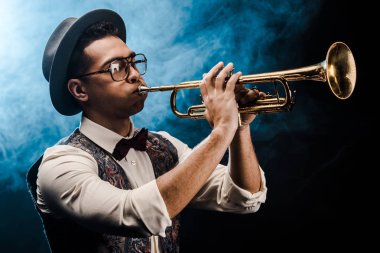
[222, 168, 267, 213]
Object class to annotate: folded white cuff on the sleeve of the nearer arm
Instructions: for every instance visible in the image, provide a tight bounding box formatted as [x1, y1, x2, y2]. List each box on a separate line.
[132, 180, 172, 237]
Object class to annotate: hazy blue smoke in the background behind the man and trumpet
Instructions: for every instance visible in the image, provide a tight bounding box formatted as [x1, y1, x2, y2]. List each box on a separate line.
[0, 0, 320, 189]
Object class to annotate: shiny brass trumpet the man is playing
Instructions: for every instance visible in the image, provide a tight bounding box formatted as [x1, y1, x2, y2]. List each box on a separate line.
[139, 42, 356, 119]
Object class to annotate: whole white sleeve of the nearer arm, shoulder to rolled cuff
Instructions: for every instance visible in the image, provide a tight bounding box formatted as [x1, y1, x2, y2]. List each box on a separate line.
[37, 145, 171, 236]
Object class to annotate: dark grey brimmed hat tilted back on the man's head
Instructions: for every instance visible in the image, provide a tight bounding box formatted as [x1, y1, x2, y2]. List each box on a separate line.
[42, 9, 126, 116]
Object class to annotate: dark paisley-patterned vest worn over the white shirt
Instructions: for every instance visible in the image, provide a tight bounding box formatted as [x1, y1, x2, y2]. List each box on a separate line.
[27, 129, 179, 253]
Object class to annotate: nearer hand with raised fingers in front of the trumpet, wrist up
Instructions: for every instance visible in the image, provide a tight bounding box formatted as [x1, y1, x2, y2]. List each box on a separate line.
[200, 62, 242, 137]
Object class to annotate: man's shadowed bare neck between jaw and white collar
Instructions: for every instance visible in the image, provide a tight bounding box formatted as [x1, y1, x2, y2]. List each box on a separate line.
[84, 114, 132, 137]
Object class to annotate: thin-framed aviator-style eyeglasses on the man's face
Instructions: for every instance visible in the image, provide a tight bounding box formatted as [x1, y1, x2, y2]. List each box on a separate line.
[74, 54, 147, 82]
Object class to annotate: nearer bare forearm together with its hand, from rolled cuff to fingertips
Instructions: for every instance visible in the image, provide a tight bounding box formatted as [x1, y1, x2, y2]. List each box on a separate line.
[157, 62, 241, 218]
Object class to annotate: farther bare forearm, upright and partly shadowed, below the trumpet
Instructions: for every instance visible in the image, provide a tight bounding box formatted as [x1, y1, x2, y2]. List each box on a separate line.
[230, 125, 261, 193]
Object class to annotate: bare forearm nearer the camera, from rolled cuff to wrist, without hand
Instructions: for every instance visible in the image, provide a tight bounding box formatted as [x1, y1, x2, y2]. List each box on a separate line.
[157, 128, 232, 217]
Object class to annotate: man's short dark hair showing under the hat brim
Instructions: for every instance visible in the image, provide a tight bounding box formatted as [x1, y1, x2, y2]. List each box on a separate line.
[67, 21, 118, 78]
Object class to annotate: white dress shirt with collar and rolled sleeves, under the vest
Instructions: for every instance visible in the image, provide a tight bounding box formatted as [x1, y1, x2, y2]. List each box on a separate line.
[37, 117, 267, 252]
